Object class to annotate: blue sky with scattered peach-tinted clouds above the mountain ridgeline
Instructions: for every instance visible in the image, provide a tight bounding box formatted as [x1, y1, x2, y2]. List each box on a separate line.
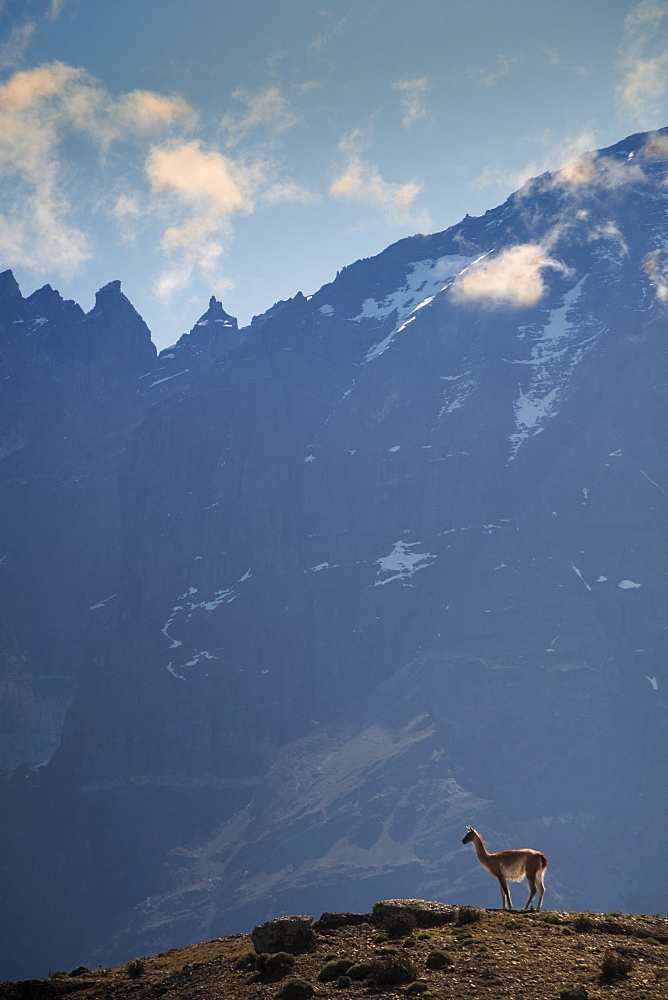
[0, 0, 668, 347]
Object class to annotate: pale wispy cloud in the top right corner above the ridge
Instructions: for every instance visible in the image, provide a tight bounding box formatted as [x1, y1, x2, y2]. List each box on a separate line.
[616, 0, 668, 128]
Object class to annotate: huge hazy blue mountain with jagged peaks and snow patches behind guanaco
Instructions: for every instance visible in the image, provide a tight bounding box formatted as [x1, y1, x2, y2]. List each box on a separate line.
[0, 132, 668, 976]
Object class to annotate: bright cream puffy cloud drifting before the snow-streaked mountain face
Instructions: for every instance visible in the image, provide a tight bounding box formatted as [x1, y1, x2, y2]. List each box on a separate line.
[451, 243, 568, 309]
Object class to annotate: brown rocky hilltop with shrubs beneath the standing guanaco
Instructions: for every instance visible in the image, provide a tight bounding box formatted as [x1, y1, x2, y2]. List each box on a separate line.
[0, 900, 668, 1000]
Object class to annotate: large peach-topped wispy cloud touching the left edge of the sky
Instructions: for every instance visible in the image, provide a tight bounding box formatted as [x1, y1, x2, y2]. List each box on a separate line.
[0, 62, 194, 276]
